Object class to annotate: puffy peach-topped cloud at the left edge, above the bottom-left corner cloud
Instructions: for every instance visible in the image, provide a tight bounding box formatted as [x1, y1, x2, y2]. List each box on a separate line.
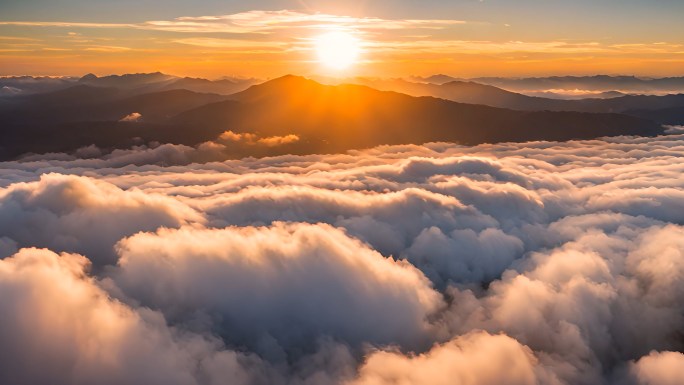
[0, 174, 202, 266]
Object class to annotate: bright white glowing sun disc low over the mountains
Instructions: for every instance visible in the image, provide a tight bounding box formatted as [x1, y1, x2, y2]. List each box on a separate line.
[316, 31, 361, 70]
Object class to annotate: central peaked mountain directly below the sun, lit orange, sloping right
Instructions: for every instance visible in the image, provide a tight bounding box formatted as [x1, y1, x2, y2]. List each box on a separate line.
[172, 76, 662, 152]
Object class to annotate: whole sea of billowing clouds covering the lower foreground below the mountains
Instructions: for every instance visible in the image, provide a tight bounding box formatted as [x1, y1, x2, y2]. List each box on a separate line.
[0, 133, 684, 385]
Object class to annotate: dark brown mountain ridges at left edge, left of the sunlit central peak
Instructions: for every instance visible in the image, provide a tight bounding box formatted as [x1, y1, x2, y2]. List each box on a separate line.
[0, 85, 235, 160]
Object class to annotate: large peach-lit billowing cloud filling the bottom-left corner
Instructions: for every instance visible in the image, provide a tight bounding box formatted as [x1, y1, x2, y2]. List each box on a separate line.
[0, 249, 265, 385]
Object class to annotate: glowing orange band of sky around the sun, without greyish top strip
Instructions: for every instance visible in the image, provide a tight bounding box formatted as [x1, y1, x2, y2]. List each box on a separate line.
[0, 11, 684, 78]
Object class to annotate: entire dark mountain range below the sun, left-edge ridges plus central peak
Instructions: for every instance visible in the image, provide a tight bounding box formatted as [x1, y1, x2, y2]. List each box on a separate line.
[0, 76, 663, 159]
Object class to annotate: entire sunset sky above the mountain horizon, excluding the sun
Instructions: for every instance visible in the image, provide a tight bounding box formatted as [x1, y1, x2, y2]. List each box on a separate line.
[0, 0, 684, 78]
